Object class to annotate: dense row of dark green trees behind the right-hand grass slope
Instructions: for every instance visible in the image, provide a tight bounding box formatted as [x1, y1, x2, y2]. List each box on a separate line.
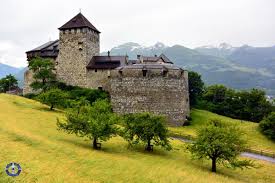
[196, 85, 272, 122]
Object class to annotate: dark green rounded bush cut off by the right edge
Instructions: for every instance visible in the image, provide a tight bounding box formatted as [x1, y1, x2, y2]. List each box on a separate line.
[259, 112, 275, 141]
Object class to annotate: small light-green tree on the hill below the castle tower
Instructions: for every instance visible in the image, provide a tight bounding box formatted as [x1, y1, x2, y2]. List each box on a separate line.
[37, 89, 68, 110]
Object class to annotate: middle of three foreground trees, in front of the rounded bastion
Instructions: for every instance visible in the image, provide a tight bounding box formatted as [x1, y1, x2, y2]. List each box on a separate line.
[123, 113, 171, 151]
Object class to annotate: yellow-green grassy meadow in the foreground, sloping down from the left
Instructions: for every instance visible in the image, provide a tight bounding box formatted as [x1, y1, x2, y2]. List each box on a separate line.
[0, 94, 275, 183]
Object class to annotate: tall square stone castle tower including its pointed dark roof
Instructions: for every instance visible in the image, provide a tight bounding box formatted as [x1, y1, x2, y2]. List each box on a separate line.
[56, 13, 100, 87]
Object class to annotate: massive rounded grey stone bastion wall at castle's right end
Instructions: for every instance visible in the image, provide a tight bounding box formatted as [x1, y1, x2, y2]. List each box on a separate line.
[110, 69, 190, 126]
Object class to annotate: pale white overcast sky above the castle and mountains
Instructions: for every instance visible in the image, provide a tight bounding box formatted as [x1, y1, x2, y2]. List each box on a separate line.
[0, 0, 275, 67]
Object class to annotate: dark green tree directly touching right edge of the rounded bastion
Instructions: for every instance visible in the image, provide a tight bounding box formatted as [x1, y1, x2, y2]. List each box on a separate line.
[188, 71, 204, 106]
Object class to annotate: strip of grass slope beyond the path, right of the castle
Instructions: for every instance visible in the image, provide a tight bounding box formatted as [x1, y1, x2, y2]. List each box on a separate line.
[169, 109, 275, 153]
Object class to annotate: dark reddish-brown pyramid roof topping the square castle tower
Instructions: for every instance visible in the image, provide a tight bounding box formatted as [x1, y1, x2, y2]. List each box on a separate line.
[58, 13, 100, 33]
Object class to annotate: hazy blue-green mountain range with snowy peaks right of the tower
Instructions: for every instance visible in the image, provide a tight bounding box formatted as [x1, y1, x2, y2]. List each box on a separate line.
[102, 42, 275, 95]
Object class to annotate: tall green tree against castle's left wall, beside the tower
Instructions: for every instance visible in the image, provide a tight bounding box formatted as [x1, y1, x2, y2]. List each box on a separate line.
[29, 57, 56, 91]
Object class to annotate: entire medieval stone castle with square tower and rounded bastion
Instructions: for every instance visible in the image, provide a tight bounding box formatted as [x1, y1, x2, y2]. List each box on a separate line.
[23, 13, 190, 126]
